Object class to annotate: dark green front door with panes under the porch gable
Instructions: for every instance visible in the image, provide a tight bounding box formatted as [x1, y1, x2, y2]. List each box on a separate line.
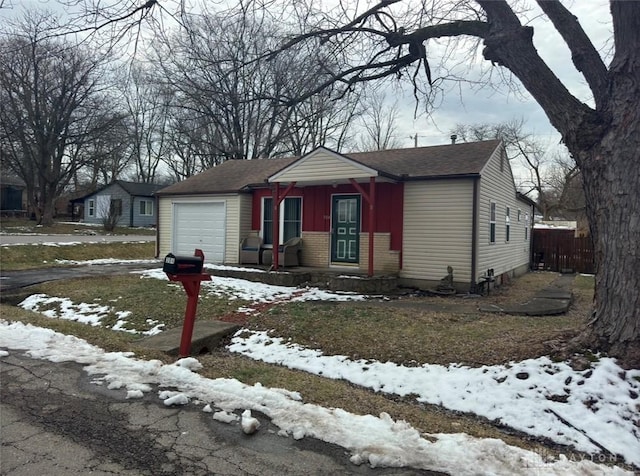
[331, 195, 360, 263]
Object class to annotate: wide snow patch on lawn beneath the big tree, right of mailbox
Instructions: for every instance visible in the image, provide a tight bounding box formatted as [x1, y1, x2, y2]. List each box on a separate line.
[229, 330, 640, 466]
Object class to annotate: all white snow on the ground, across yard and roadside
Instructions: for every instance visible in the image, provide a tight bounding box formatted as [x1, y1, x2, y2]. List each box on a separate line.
[0, 262, 640, 476]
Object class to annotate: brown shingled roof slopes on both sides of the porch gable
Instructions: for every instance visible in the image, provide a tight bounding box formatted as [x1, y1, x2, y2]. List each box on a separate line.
[157, 140, 500, 195]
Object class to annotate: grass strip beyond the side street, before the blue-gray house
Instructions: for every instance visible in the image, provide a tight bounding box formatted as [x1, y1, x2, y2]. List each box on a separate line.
[0, 217, 156, 235]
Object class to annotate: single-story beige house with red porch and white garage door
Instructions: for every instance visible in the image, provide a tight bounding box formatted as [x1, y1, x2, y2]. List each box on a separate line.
[157, 140, 533, 290]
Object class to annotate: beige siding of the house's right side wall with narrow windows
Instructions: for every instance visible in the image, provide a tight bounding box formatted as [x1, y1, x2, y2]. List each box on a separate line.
[476, 148, 532, 280]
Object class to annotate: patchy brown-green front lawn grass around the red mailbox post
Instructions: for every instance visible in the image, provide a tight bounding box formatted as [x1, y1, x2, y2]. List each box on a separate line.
[0, 256, 593, 462]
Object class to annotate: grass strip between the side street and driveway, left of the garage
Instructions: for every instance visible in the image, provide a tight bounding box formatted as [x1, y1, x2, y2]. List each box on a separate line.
[0, 241, 156, 271]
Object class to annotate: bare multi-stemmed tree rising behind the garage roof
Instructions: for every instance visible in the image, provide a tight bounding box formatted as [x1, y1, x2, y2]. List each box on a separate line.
[156, 6, 358, 164]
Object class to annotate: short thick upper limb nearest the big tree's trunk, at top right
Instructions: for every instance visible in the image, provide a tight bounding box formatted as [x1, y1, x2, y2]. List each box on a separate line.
[537, 0, 607, 109]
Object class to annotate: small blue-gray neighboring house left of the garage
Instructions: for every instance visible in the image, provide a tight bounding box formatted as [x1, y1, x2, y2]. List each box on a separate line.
[74, 180, 163, 226]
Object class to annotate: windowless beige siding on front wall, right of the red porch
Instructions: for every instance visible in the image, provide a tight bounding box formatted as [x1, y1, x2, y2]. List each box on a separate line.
[400, 179, 473, 282]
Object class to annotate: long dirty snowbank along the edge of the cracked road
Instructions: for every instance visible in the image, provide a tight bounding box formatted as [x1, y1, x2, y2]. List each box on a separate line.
[0, 321, 631, 476]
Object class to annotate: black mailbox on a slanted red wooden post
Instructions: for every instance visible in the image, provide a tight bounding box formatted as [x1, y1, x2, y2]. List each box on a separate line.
[162, 249, 211, 357]
